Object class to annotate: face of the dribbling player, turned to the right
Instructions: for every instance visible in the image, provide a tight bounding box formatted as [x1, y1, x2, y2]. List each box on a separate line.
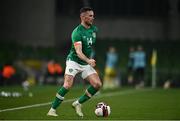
[83, 11, 94, 26]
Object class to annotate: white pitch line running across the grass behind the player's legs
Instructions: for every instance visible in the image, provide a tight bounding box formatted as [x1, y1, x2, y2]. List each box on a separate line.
[0, 89, 148, 112]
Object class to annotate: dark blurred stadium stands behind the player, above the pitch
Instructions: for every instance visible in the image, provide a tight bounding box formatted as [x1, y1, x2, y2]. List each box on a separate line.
[0, 0, 180, 86]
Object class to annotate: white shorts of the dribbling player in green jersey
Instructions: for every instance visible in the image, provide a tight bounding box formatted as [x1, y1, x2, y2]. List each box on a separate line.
[65, 60, 97, 79]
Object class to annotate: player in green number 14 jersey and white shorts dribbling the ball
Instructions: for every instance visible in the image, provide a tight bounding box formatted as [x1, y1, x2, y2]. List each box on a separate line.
[47, 7, 102, 117]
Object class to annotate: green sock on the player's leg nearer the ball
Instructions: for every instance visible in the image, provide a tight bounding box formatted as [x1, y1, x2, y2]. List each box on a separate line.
[78, 85, 98, 104]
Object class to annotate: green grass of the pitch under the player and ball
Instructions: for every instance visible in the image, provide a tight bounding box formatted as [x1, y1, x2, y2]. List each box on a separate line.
[0, 86, 180, 120]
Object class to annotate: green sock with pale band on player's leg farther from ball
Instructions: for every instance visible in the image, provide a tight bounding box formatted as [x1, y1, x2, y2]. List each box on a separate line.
[52, 87, 69, 109]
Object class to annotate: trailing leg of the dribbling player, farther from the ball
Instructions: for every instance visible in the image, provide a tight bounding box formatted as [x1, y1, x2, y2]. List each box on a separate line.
[47, 74, 74, 116]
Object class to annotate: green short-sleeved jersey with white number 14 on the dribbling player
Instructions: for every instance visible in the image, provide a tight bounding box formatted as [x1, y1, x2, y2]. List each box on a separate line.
[67, 24, 97, 65]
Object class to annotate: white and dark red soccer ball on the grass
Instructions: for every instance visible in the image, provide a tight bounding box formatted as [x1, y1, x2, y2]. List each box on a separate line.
[95, 102, 111, 117]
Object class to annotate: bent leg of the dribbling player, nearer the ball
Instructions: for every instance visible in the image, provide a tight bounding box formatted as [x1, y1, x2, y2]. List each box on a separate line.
[72, 73, 102, 117]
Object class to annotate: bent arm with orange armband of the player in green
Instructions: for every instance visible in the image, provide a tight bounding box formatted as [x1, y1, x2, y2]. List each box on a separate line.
[74, 41, 96, 67]
